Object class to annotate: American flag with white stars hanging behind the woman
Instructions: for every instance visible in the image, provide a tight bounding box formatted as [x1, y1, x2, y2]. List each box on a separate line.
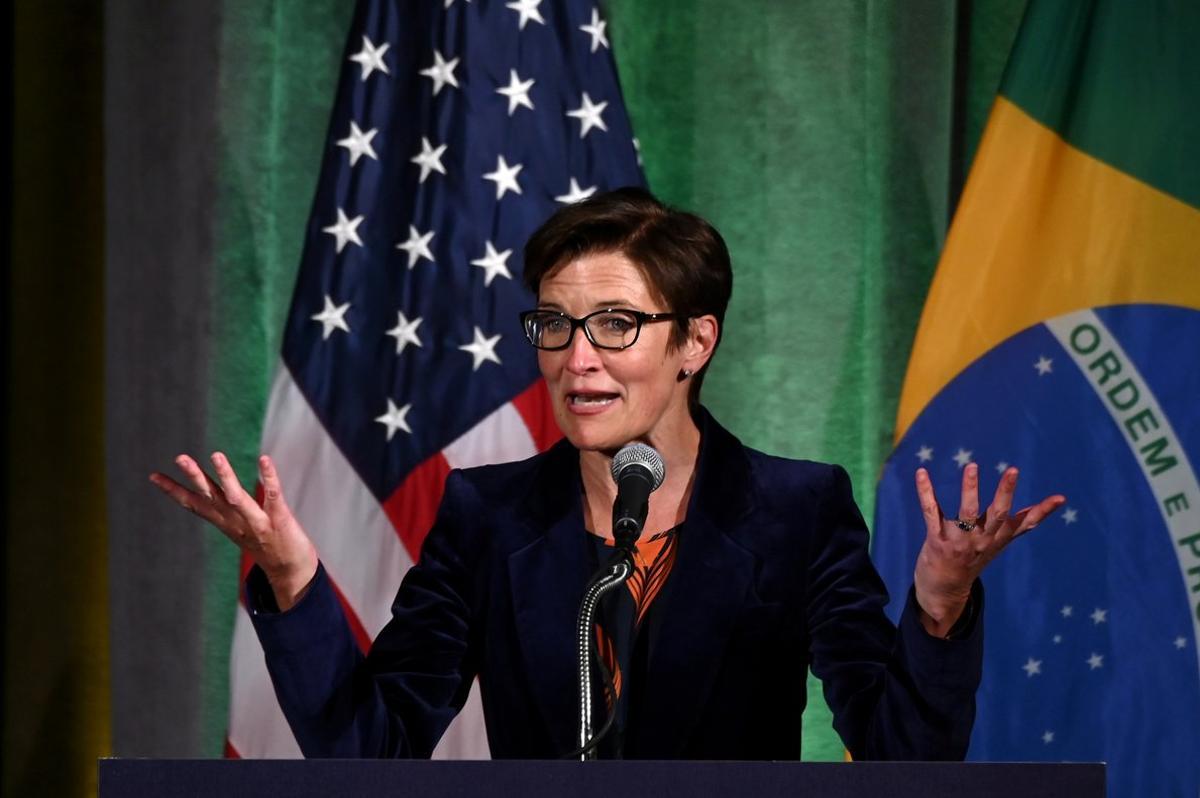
[227, 0, 643, 757]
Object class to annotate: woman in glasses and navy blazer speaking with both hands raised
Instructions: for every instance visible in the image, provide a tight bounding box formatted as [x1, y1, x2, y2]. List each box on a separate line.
[151, 190, 1064, 760]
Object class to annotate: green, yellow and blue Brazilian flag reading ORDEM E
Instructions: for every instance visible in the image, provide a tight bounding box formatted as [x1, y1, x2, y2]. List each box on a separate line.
[874, 0, 1200, 798]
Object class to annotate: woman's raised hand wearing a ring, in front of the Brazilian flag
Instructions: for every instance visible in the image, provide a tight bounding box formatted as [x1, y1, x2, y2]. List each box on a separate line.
[913, 463, 1067, 637]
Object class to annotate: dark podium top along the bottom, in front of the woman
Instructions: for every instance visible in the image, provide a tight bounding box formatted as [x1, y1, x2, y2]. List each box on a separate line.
[100, 760, 1104, 798]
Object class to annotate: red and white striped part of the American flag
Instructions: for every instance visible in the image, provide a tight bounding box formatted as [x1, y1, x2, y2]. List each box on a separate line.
[226, 364, 562, 758]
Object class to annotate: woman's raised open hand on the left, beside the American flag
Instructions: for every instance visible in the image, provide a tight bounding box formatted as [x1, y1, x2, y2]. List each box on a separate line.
[150, 451, 317, 611]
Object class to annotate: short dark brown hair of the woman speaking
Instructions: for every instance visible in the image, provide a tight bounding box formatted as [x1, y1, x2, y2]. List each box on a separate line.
[524, 187, 733, 409]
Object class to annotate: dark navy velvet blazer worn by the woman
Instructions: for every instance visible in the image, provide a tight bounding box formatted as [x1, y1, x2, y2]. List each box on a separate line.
[247, 412, 983, 760]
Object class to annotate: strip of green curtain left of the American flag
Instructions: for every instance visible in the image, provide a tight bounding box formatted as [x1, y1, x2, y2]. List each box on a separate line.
[202, 0, 353, 755]
